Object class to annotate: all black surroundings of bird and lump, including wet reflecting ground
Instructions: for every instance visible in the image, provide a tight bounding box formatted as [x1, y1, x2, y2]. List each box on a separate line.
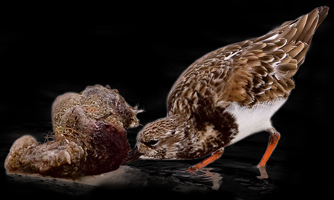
[0, 2, 334, 199]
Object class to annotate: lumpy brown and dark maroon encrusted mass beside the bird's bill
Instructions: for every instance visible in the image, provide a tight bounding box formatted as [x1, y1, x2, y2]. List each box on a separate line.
[5, 85, 140, 179]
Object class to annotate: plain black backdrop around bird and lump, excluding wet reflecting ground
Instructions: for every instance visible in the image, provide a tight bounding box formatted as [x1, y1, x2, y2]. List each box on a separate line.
[0, 1, 334, 198]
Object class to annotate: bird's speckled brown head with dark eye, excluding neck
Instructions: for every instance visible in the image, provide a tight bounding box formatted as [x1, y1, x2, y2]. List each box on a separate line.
[130, 116, 194, 159]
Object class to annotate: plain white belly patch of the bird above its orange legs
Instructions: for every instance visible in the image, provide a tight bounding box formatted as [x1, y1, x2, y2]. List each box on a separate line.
[224, 99, 286, 145]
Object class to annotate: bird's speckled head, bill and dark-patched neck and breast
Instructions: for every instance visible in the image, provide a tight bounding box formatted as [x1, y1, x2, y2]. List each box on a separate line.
[125, 112, 228, 163]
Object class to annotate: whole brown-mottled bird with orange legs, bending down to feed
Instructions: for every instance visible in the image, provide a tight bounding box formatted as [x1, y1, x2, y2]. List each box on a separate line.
[127, 6, 329, 171]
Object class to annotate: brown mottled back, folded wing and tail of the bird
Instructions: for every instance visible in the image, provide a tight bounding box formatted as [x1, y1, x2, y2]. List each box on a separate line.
[167, 7, 328, 115]
